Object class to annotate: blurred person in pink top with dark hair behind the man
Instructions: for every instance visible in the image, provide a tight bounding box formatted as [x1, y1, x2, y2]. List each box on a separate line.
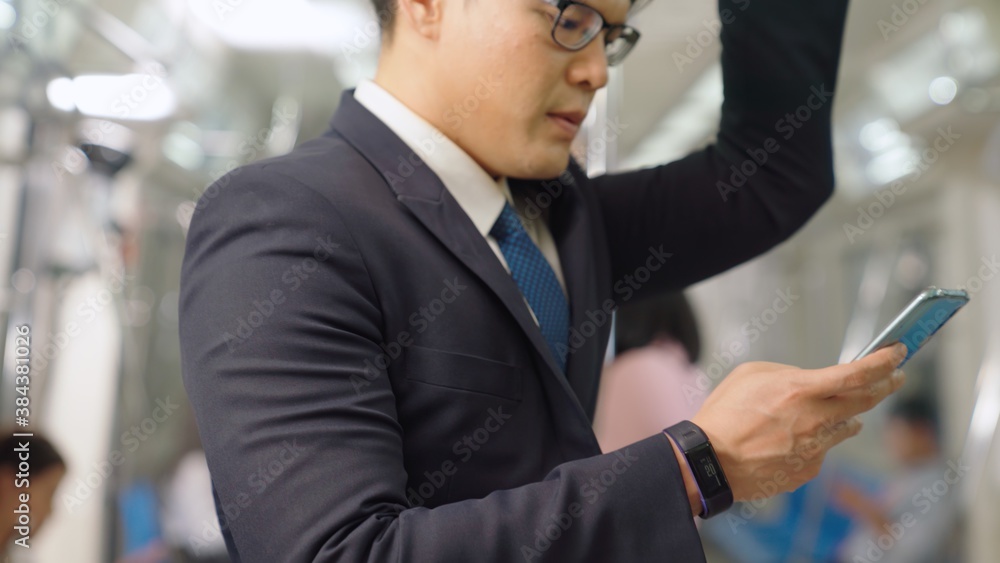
[594, 292, 707, 452]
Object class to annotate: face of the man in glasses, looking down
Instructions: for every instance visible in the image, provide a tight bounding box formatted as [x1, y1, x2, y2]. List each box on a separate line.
[424, 0, 630, 179]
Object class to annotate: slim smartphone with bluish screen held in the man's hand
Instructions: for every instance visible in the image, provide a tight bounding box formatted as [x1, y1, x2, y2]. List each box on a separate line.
[854, 287, 969, 367]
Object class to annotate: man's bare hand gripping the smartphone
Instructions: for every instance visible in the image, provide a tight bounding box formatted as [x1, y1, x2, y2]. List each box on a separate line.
[692, 344, 906, 510]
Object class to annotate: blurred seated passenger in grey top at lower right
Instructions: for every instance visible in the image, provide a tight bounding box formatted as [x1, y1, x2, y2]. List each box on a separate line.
[834, 397, 965, 563]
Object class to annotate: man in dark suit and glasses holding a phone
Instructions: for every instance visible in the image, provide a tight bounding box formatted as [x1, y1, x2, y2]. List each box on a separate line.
[180, 0, 902, 563]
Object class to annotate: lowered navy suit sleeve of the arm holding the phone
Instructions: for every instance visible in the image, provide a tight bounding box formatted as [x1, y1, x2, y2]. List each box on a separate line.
[180, 167, 704, 563]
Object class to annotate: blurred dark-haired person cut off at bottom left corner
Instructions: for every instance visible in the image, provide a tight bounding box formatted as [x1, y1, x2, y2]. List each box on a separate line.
[0, 429, 66, 559]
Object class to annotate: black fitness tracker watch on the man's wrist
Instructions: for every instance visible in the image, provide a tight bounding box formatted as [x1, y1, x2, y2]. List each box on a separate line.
[663, 420, 733, 519]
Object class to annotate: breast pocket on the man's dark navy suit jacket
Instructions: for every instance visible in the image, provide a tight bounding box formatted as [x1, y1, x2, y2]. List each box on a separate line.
[402, 345, 524, 401]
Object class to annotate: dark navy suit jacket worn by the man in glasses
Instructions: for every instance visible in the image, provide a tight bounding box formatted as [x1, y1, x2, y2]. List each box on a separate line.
[180, 0, 846, 563]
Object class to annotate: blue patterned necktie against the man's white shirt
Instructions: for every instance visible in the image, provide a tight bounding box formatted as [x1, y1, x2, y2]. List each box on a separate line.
[490, 203, 569, 373]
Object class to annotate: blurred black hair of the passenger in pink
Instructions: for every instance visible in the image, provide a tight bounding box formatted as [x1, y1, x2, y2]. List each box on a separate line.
[615, 292, 701, 362]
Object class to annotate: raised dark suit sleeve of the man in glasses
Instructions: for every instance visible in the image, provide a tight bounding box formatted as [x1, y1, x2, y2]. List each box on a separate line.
[592, 0, 847, 304]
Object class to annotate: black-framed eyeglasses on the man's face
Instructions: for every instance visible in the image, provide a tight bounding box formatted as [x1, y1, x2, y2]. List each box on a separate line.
[544, 0, 640, 66]
